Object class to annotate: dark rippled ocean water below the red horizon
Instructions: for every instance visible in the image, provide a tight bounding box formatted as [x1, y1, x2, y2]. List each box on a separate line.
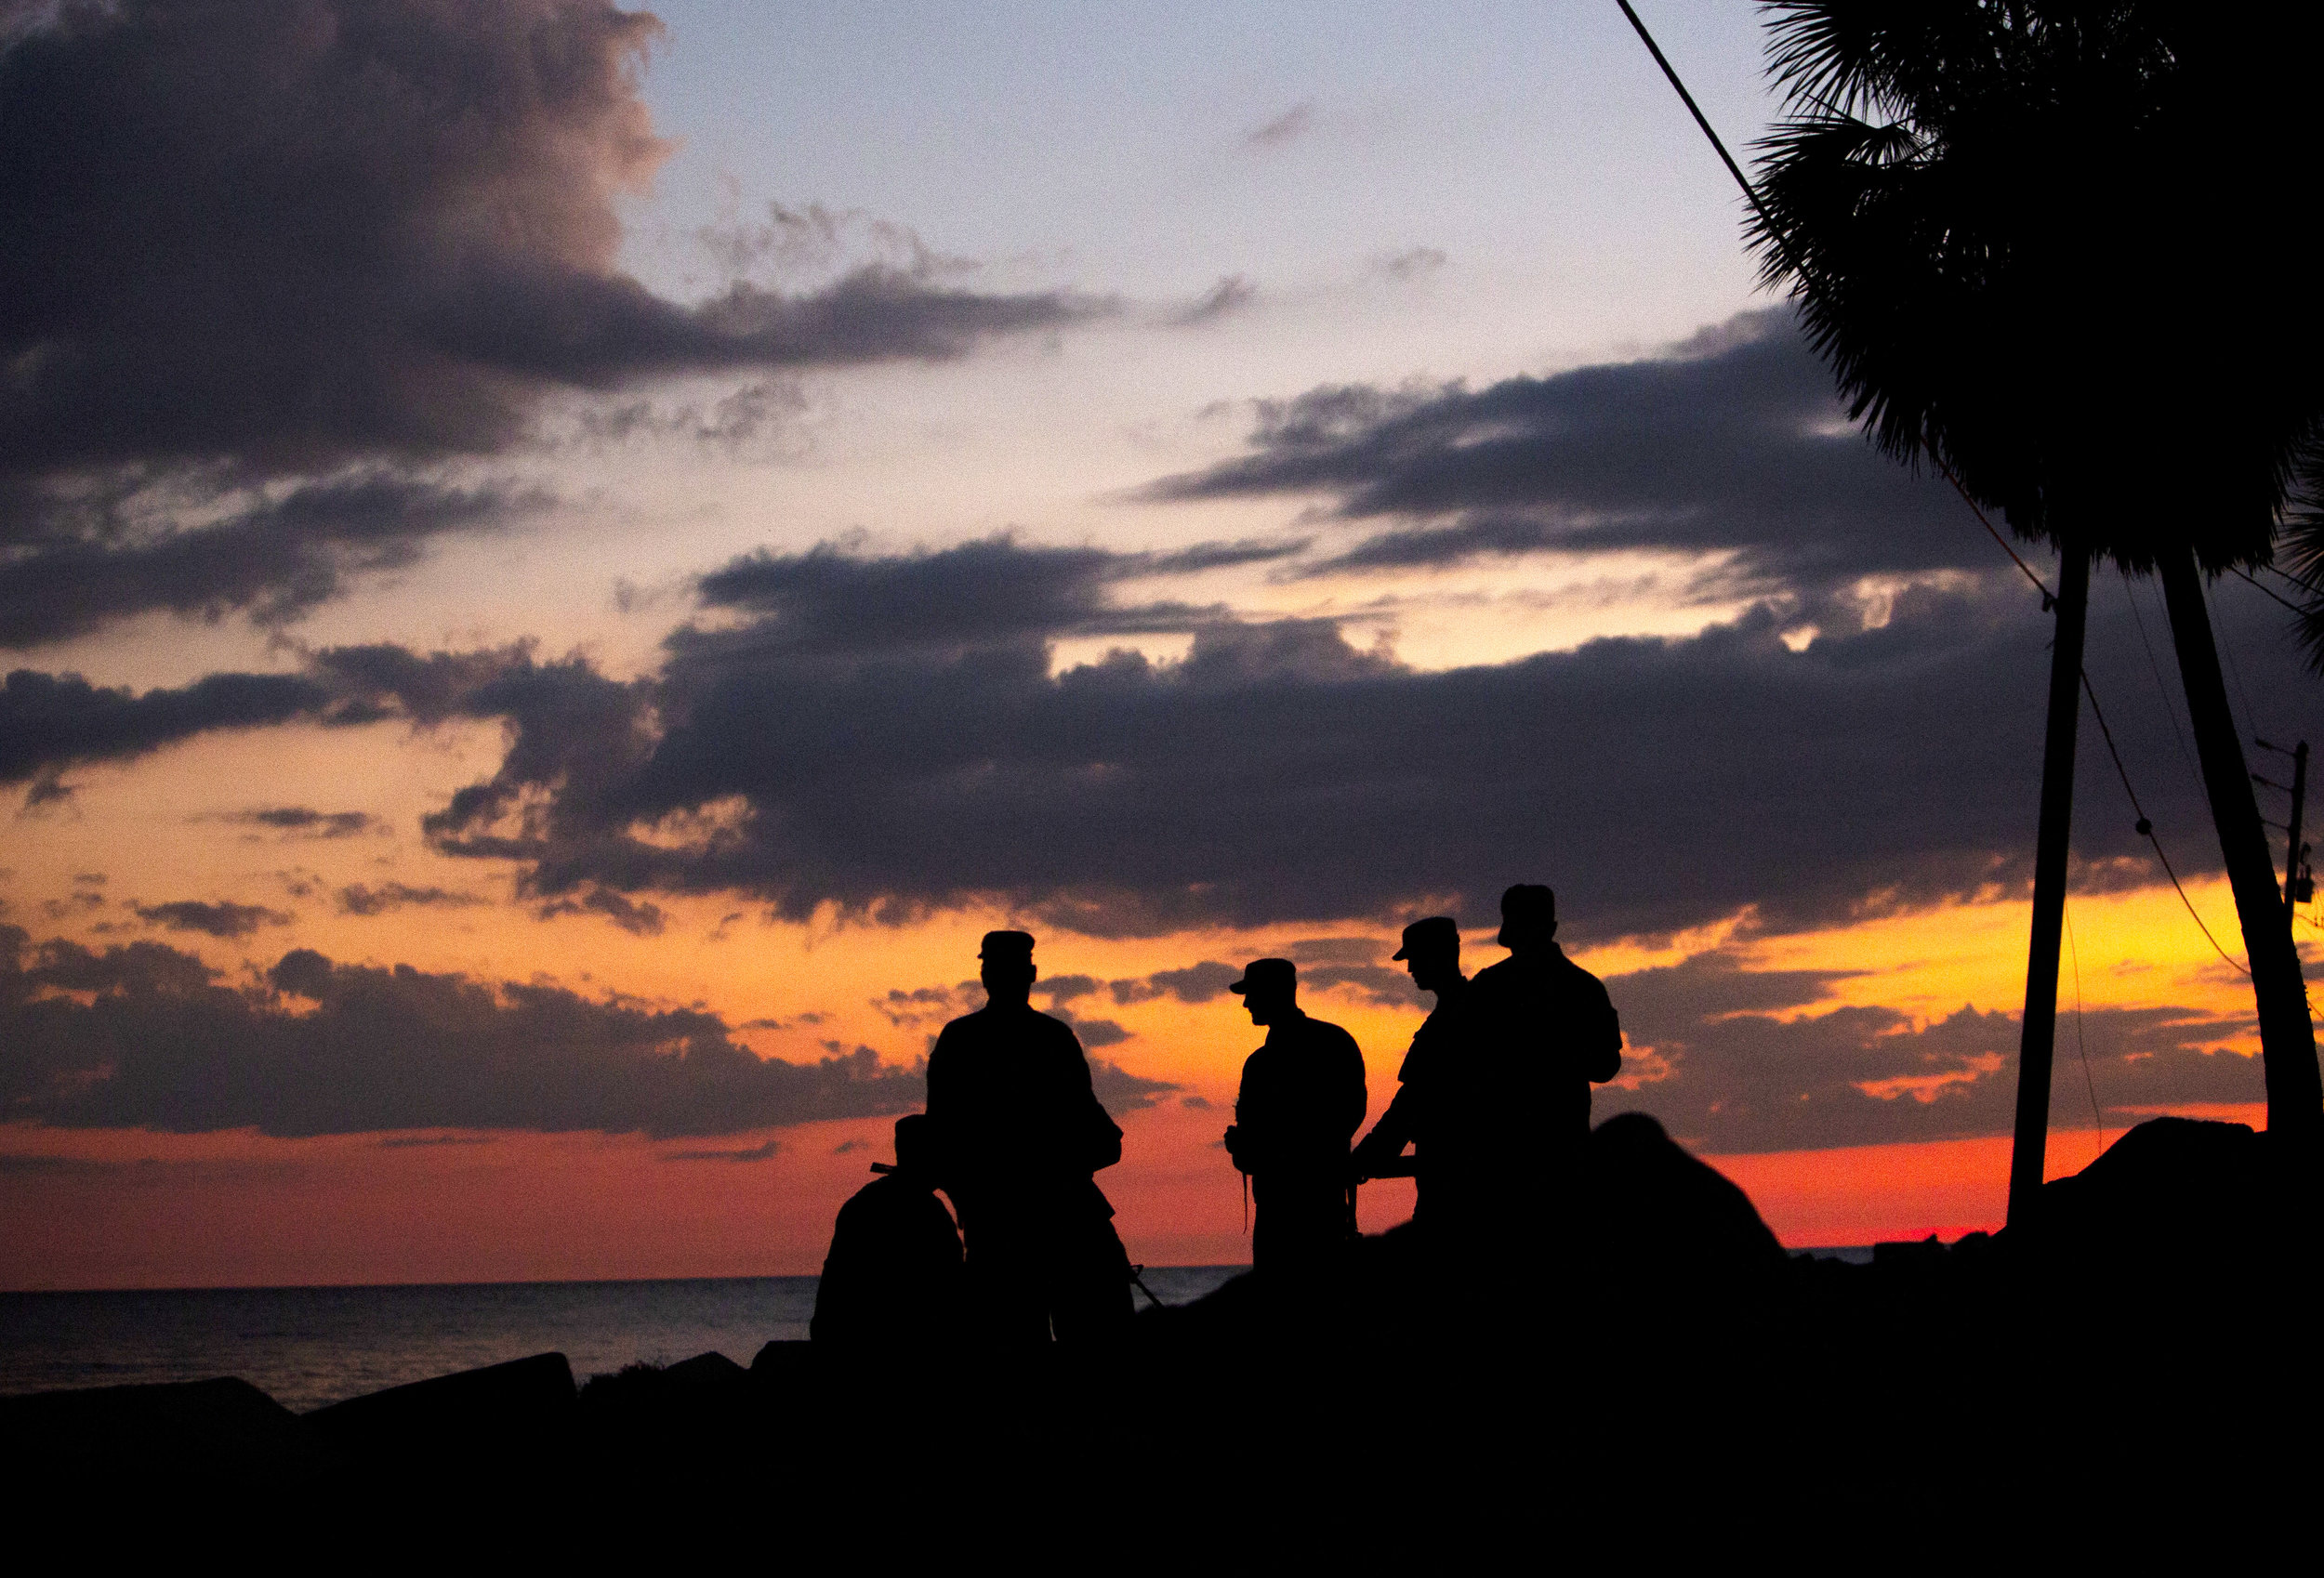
[0, 1267, 1244, 1411]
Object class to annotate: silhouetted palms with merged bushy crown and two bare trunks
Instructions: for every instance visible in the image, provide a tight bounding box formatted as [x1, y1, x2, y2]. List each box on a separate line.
[1752, 0, 2324, 1220]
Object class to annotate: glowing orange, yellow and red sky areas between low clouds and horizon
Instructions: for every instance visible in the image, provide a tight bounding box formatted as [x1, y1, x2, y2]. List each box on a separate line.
[0, 725, 2308, 1287]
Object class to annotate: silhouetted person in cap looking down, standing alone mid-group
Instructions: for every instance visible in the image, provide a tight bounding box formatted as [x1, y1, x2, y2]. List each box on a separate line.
[1227, 960, 1365, 1271]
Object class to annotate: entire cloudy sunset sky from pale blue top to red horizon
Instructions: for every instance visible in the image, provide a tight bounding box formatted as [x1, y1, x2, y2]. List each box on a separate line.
[0, 0, 2324, 1287]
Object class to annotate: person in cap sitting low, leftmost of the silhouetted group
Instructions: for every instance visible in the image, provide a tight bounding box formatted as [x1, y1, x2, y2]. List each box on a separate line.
[807, 1115, 962, 1350]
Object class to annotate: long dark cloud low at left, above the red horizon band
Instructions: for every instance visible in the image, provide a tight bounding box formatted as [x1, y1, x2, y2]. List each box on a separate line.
[0, 927, 925, 1138]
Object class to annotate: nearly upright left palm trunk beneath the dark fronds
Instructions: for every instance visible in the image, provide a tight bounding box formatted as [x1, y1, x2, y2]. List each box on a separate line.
[2011, 544, 2090, 1234]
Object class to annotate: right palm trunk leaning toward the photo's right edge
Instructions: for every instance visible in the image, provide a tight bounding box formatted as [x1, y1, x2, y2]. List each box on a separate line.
[2157, 551, 2324, 1160]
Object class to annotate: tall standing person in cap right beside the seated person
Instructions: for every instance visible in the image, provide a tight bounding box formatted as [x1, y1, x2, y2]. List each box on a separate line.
[928, 932, 1132, 1343]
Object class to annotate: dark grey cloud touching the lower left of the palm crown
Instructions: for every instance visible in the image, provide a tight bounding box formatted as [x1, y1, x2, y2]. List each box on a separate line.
[1146, 309, 1989, 590]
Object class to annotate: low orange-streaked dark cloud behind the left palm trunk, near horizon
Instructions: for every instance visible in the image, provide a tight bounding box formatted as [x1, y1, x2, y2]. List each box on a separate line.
[1594, 953, 2264, 1152]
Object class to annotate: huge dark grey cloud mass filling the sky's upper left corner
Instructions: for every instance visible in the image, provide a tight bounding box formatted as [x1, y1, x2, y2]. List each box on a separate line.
[0, 0, 1106, 646]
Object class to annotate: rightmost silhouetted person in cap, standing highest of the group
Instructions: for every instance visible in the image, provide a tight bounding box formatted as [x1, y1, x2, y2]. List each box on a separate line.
[1459, 883, 1622, 1245]
